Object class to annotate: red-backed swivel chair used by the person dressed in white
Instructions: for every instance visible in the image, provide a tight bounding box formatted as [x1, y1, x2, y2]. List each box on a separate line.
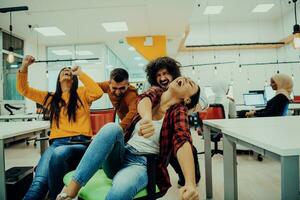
[198, 104, 225, 157]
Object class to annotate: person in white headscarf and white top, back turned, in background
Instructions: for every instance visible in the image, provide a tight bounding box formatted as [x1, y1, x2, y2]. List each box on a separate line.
[212, 80, 236, 119]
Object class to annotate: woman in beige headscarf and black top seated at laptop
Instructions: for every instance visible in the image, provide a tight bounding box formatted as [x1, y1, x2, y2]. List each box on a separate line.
[245, 74, 293, 117]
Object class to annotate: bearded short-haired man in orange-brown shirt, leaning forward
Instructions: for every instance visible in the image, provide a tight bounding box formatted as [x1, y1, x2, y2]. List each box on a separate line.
[98, 68, 138, 130]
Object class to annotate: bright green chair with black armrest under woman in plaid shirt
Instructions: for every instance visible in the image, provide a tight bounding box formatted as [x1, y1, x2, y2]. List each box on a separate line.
[64, 153, 164, 200]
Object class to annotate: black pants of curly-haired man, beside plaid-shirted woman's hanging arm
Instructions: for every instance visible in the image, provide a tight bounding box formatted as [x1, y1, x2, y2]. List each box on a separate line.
[170, 145, 201, 186]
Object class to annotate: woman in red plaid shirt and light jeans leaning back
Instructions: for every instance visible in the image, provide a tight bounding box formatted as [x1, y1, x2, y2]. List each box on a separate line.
[57, 77, 200, 200]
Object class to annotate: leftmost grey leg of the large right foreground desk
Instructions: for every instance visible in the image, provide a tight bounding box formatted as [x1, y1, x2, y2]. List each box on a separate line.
[204, 125, 213, 199]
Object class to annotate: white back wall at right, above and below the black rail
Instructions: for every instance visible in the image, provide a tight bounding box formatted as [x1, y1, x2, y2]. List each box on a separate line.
[176, 10, 300, 104]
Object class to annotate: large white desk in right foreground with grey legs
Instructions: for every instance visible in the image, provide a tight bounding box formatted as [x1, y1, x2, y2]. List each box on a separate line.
[204, 116, 300, 200]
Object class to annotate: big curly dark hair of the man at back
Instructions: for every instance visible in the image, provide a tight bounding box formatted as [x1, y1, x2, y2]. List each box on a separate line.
[145, 57, 181, 86]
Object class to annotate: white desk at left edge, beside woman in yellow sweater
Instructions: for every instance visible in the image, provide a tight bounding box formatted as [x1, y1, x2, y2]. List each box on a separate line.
[0, 121, 50, 200]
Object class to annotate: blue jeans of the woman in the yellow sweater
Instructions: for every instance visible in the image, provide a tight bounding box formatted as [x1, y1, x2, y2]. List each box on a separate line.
[24, 136, 89, 200]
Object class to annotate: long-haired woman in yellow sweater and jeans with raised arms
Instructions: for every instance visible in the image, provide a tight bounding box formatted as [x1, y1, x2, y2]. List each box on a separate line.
[17, 56, 103, 200]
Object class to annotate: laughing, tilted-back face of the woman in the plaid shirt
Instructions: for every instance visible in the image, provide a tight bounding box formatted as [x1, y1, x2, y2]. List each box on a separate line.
[169, 76, 199, 103]
